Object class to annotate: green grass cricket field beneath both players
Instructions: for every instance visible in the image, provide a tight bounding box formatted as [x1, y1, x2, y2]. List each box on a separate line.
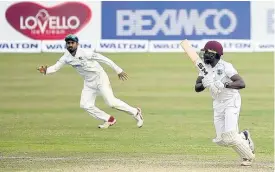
[0, 53, 274, 172]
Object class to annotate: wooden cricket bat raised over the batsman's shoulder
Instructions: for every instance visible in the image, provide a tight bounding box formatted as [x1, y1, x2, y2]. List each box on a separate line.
[180, 39, 208, 76]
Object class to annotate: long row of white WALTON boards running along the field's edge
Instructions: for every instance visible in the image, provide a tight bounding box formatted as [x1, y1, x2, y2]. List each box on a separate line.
[0, 40, 275, 53]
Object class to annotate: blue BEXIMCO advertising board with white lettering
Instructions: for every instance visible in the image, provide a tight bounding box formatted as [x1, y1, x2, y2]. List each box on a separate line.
[102, 1, 250, 40]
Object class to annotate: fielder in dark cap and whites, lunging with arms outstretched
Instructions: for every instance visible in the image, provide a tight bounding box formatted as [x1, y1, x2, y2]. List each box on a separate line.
[38, 35, 143, 128]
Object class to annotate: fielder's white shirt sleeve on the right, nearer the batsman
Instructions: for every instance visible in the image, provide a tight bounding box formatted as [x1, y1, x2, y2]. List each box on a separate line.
[88, 53, 123, 74]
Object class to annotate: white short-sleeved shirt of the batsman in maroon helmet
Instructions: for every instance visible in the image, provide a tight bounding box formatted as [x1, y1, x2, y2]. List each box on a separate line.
[199, 59, 240, 108]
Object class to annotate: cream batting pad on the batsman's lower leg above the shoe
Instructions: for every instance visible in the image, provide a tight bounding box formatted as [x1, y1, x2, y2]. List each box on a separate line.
[222, 131, 255, 160]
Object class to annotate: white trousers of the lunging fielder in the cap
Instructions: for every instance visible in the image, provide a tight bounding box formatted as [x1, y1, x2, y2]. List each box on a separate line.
[80, 71, 138, 122]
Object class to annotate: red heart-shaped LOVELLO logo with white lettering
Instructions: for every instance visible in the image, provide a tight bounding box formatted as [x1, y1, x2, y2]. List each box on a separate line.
[6, 2, 92, 40]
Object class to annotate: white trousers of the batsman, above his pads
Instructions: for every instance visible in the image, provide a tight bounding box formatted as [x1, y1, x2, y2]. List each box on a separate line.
[214, 95, 241, 138]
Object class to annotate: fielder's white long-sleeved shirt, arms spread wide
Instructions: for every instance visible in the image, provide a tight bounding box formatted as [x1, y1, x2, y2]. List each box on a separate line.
[46, 48, 123, 82]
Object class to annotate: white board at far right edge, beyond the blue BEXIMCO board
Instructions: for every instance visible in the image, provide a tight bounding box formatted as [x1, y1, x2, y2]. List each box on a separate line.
[251, 1, 275, 43]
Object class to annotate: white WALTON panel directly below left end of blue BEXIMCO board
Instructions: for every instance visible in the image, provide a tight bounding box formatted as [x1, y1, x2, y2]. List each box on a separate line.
[96, 40, 148, 53]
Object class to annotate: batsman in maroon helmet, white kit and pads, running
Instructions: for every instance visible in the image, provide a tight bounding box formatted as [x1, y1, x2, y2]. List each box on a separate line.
[195, 41, 255, 166]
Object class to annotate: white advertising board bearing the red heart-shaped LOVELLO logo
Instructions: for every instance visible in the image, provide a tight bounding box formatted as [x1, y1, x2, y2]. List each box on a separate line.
[0, 1, 101, 41]
